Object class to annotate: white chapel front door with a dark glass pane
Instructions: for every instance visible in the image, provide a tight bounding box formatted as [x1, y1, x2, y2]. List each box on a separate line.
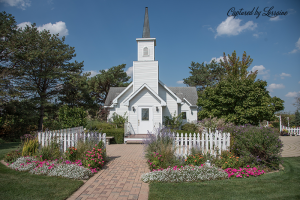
[138, 106, 153, 134]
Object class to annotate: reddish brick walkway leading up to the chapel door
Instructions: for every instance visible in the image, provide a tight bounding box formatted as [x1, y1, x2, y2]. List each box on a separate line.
[68, 144, 149, 200]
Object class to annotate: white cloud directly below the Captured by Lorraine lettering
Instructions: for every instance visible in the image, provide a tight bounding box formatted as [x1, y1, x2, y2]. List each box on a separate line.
[215, 16, 257, 38]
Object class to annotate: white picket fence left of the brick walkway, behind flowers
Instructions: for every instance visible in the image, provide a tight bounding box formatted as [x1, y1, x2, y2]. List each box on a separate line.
[38, 126, 106, 152]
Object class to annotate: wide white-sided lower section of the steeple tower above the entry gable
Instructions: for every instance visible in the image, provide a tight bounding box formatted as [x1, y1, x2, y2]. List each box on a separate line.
[133, 61, 158, 93]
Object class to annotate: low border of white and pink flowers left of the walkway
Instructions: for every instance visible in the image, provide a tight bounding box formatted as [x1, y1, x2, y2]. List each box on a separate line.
[8, 156, 97, 179]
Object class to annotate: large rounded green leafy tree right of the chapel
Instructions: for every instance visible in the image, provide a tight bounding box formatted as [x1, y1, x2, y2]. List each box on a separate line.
[198, 51, 284, 125]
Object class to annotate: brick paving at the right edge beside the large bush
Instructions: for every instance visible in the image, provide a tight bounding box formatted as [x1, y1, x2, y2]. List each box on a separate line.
[279, 136, 300, 157]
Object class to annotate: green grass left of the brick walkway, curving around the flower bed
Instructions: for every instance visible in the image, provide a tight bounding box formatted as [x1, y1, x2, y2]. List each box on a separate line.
[0, 142, 83, 200]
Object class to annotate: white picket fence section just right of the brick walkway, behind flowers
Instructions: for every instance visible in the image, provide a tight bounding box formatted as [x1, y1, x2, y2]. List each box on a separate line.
[166, 129, 230, 157]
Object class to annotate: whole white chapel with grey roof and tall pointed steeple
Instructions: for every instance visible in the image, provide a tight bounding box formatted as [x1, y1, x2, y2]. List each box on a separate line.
[104, 7, 198, 142]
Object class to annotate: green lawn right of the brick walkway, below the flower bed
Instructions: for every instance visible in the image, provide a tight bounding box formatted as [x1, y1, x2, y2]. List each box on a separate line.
[149, 157, 300, 200]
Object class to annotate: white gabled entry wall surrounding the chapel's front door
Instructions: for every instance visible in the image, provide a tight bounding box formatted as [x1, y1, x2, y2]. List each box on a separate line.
[129, 88, 161, 133]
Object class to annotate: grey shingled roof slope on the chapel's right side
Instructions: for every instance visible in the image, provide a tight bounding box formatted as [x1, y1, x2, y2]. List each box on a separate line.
[169, 87, 198, 106]
